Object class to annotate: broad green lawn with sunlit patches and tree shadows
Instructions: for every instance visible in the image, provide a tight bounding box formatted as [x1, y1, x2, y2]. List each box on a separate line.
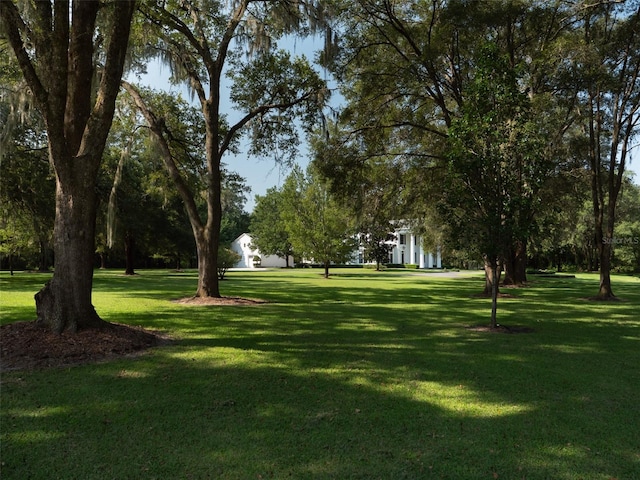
[0, 269, 640, 480]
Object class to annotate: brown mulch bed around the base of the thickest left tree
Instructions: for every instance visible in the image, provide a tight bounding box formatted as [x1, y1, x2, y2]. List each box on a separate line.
[0, 322, 172, 371]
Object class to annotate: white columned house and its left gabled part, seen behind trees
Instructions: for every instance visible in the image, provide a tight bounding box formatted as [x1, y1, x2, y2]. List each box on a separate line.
[231, 227, 442, 268]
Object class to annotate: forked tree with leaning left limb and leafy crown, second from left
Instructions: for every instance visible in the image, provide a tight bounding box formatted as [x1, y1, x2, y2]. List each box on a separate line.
[123, 0, 327, 297]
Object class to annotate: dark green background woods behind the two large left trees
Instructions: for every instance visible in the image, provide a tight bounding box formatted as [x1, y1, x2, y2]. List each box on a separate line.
[0, 99, 250, 273]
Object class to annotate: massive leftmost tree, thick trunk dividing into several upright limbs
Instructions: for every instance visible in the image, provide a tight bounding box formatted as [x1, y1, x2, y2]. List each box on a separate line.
[0, 0, 135, 332]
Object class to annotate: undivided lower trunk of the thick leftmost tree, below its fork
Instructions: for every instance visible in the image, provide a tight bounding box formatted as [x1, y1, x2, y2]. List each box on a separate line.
[35, 176, 106, 333]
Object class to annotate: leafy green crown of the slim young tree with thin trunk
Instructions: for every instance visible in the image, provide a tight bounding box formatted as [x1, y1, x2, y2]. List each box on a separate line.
[445, 39, 544, 257]
